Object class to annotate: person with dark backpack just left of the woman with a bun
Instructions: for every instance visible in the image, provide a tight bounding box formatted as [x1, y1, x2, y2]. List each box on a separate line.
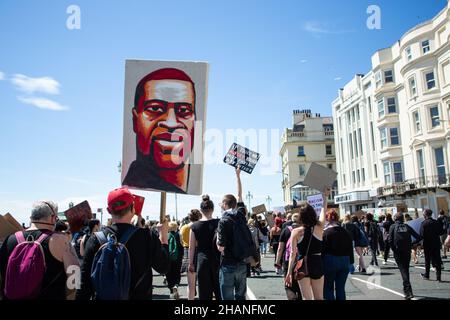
[166, 221, 184, 300]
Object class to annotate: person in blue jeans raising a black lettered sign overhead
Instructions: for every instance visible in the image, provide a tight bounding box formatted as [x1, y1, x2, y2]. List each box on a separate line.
[217, 168, 256, 300]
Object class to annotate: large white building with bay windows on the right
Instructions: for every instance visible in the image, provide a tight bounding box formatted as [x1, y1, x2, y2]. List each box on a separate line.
[332, 2, 450, 213]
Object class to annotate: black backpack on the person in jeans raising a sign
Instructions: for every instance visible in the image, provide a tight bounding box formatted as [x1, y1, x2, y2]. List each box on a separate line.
[226, 212, 256, 262]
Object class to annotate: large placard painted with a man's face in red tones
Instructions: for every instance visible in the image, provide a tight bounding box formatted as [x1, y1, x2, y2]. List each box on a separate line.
[121, 60, 209, 195]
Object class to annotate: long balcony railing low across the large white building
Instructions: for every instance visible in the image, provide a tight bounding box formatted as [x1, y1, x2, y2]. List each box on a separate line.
[377, 174, 450, 197]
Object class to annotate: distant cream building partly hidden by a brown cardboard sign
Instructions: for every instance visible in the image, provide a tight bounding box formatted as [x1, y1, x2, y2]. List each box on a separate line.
[280, 110, 337, 205]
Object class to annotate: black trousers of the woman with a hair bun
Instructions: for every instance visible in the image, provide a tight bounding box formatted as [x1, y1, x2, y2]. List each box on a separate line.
[197, 251, 222, 300]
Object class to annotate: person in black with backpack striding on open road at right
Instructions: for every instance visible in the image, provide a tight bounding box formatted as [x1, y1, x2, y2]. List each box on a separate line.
[387, 212, 422, 300]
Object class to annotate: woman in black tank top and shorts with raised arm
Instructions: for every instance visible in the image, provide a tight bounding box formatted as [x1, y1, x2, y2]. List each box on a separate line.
[285, 187, 330, 300]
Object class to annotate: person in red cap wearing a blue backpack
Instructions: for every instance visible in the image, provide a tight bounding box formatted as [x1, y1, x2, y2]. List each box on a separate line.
[76, 187, 169, 300]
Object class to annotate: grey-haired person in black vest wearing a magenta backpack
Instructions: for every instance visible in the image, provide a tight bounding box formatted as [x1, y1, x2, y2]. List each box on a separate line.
[0, 201, 79, 300]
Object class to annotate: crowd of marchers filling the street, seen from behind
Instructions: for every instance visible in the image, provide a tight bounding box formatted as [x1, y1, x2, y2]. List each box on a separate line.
[0, 169, 450, 300]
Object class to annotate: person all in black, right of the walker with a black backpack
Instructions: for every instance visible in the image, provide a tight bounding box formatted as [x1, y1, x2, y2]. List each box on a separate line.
[420, 209, 442, 282]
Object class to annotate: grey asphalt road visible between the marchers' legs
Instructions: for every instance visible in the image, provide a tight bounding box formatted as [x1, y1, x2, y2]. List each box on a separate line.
[153, 250, 450, 300]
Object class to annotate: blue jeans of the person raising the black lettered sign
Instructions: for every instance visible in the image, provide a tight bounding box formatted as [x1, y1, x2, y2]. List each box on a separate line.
[219, 263, 247, 300]
